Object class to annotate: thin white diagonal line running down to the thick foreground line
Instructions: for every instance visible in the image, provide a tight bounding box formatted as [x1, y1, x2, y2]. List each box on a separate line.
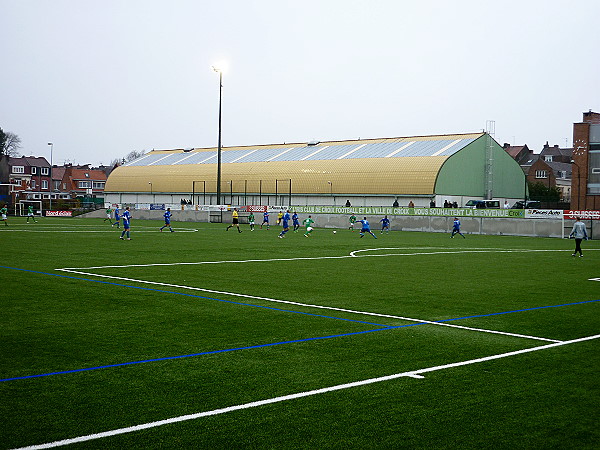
[56, 268, 561, 342]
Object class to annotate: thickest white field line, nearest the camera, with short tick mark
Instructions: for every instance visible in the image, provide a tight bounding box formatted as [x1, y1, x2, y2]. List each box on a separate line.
[16, 334, 600, 450]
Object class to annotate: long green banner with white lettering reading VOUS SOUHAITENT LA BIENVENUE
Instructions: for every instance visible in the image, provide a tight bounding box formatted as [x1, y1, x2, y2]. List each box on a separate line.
[290, 206, 524, 218]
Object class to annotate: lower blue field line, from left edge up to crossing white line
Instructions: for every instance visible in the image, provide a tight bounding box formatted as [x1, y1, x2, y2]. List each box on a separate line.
[0, 323, 412, 382]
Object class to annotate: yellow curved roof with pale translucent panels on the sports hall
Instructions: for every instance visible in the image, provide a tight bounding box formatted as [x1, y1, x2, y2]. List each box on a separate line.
[105, 133, 482, 195]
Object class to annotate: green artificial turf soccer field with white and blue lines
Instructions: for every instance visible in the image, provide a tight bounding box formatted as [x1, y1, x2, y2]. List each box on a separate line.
[0, 215, 600, 449]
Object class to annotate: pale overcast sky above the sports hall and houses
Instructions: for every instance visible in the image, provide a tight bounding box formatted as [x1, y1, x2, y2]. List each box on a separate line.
[0, 0, 600, 165]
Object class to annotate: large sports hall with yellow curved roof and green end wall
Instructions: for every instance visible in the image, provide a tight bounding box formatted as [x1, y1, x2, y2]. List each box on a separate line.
[105, 132, 526, 206]
